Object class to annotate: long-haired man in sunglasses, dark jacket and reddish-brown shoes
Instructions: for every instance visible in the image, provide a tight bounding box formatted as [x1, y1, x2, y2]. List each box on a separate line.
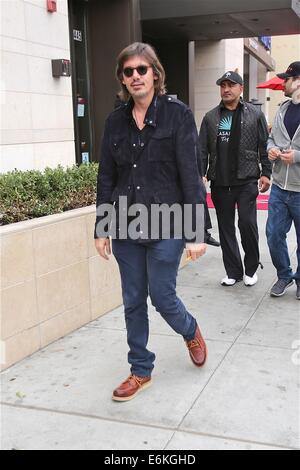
[95, 43, 207, 401]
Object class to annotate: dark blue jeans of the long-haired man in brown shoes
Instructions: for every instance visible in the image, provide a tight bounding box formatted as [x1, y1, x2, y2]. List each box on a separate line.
[112, 239, 197, 377]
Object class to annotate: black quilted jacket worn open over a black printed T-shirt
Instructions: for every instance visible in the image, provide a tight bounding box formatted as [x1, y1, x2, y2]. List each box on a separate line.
[199, 101, 271, 181]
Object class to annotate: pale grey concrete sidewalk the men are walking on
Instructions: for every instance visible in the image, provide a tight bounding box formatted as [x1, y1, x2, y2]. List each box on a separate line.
[1, 211, 300, 450]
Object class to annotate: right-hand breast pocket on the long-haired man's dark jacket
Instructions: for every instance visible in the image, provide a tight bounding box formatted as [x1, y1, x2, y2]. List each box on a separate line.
[148, 129, 175, 162]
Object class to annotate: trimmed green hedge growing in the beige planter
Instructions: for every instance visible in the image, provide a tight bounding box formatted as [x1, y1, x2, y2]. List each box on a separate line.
[0, 163, 98, 225]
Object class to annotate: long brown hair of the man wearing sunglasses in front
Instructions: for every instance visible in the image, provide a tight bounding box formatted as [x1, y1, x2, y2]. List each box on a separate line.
[116, 42, 166, 101]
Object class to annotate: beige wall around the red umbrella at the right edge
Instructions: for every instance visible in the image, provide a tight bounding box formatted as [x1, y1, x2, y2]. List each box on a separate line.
[269, 34, 300, 122]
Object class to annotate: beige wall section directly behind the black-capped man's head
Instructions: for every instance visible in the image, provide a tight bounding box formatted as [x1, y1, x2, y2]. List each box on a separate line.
[195, 39, 244, 127]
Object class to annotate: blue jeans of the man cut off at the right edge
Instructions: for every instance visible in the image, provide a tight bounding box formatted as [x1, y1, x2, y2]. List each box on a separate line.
[266, 184, 300, 281]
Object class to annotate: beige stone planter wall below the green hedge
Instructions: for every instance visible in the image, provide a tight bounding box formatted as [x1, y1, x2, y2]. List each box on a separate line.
[0, 206, 122, 370]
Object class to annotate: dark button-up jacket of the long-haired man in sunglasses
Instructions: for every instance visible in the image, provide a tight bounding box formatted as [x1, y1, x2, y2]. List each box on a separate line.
[95, 95, 205, 238]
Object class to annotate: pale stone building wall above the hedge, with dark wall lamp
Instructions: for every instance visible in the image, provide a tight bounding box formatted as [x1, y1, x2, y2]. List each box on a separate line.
[0, 0, 75, 172]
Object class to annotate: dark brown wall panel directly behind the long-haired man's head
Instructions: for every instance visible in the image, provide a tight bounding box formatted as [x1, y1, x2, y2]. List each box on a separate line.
[88, 0, 141, 160]
